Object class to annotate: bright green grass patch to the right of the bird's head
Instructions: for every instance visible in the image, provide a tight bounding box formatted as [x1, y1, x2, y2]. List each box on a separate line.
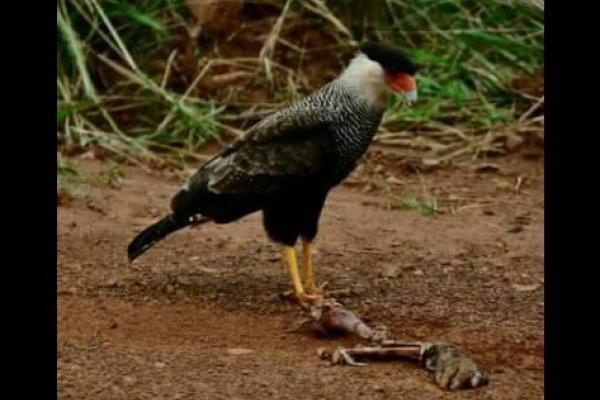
[384, 0, 544, 128]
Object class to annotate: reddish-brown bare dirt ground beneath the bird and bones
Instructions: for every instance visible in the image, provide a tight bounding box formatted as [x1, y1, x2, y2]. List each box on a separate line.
[57, 155, 544, 400]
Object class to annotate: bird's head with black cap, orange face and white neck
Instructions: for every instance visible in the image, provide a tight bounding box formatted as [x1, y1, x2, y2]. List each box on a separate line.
[341, 42, 417, 105]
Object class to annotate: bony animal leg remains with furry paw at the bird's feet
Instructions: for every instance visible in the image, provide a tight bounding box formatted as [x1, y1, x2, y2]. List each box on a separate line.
[302, 299, 488, 390]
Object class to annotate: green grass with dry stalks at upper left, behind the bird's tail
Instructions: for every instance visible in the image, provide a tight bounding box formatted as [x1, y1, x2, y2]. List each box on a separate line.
[57, 0, 219, 164]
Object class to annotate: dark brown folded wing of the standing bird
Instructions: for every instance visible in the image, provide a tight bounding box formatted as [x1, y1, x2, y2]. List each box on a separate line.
[171, 104, 334, 212]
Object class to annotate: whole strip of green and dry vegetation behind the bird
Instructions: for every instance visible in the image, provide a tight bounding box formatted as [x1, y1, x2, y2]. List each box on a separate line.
[57, 0, 544, 174]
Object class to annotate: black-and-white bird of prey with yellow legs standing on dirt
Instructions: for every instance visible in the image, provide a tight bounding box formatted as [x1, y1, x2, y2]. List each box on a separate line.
[127, 41, 418, 304]
